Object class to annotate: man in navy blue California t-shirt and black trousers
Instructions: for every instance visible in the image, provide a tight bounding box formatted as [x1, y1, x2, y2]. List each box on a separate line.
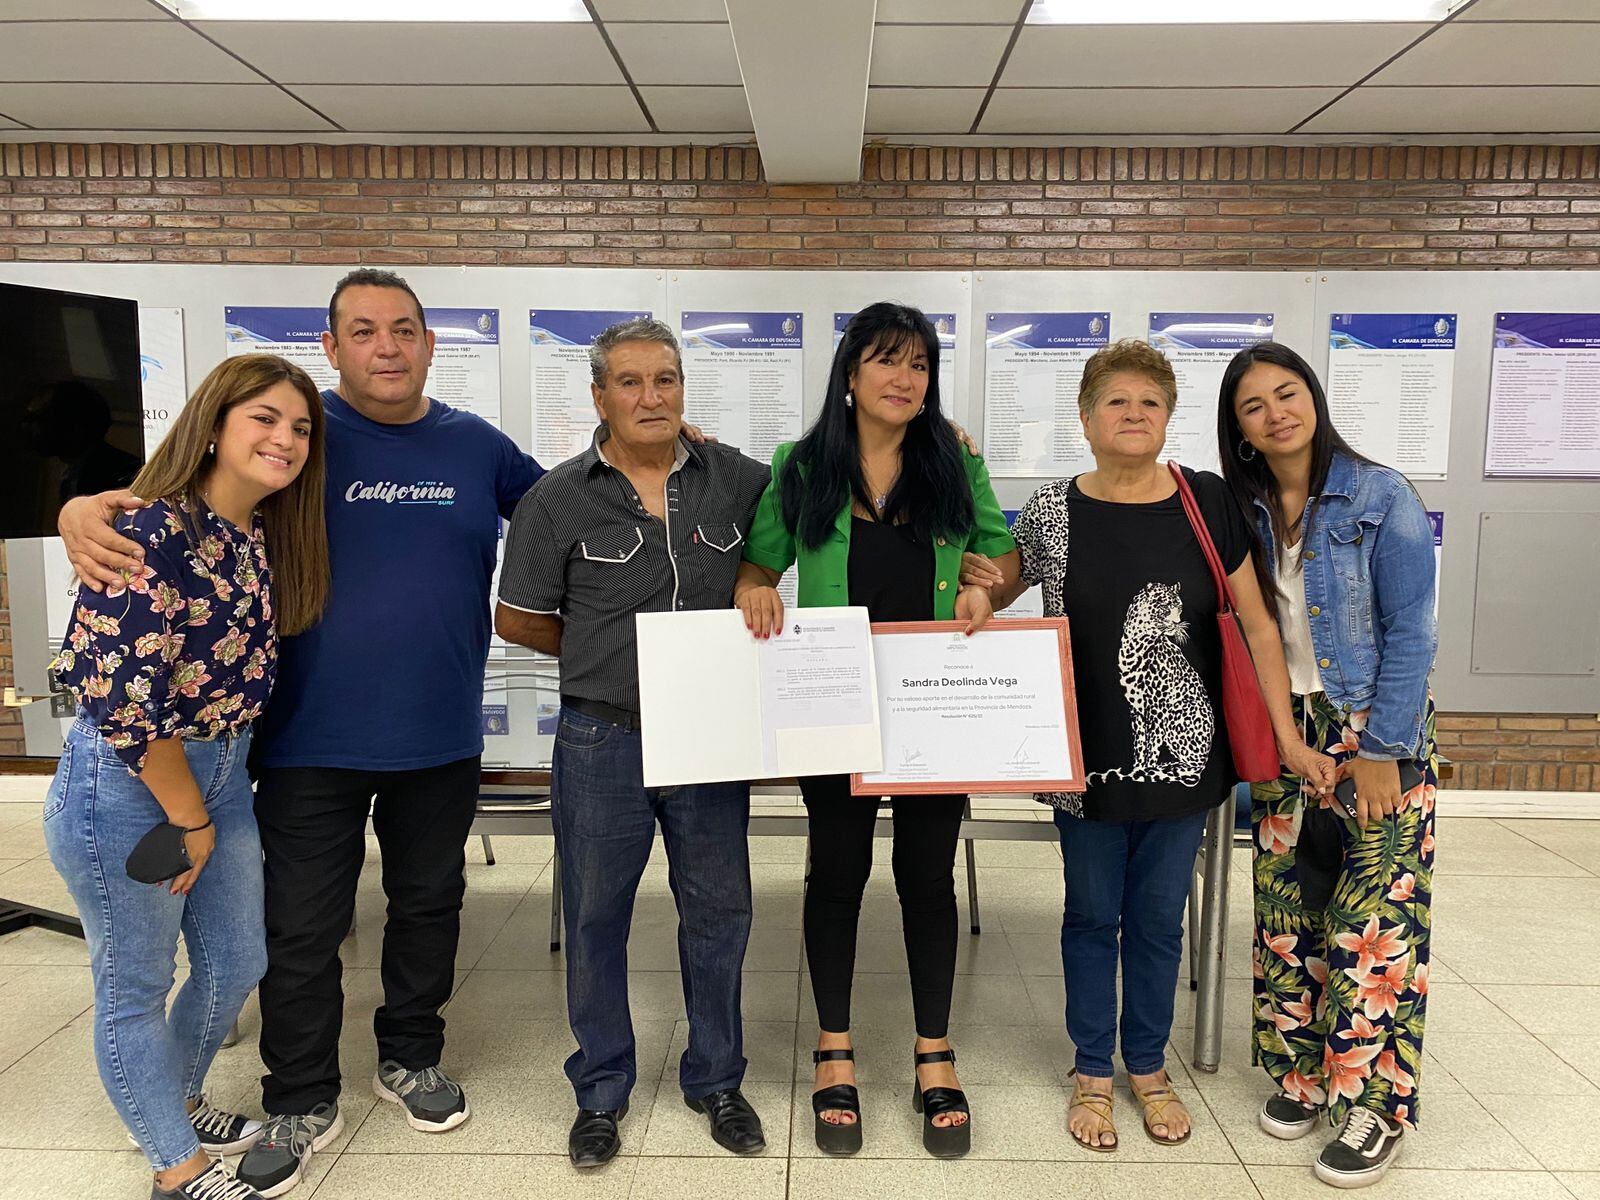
[59, 269, 542, 1197]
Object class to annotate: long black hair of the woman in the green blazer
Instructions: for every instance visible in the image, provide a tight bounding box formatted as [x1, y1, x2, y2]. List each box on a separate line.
[779, 301, 974, 550]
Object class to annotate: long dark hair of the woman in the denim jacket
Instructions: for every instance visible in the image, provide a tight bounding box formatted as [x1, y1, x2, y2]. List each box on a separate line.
[1216, 342, 1371, 616]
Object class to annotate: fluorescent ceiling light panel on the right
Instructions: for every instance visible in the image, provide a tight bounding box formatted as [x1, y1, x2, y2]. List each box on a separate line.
[1027, 0, 1462, 26]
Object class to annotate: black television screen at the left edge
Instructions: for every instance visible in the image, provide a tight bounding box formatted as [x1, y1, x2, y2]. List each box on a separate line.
[0, 283, 144, 538]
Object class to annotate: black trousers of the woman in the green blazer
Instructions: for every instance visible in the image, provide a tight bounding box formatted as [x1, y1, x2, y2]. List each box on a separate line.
[800, 774, 966, 1038]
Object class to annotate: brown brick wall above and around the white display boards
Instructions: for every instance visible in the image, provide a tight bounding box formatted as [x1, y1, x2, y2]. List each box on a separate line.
[0, 142, 1600, 790]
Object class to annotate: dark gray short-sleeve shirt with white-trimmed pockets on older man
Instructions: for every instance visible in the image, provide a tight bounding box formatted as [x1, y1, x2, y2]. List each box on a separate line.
[499, 426, 771, 712]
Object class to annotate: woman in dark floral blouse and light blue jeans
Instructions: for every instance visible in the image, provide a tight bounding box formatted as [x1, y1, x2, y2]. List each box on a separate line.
[45, 354, 328, 1200]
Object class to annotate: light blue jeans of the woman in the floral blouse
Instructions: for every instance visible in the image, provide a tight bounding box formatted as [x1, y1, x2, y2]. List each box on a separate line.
[45, 717, 267, 1171]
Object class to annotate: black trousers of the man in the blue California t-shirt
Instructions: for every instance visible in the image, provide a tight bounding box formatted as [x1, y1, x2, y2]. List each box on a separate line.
[256, 757, 480, 1115]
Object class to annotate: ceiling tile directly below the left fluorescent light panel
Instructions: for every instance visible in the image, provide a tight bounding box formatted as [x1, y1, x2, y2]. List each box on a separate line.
[197, 21, 622, 85]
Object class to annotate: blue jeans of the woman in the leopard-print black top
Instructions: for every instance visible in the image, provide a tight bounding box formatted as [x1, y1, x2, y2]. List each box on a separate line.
[1056, 810, 1206, 1078]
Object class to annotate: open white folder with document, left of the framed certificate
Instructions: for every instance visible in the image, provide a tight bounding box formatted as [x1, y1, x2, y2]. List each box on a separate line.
[635, 608, 883, 787]
